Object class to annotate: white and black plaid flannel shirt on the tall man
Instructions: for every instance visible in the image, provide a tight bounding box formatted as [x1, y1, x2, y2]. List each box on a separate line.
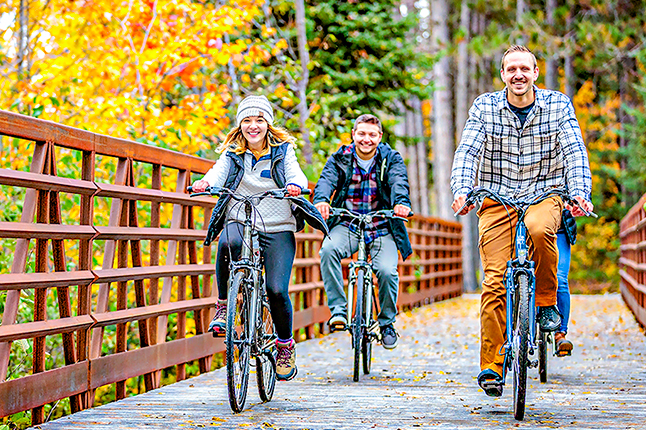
[451, 87, 592, 201]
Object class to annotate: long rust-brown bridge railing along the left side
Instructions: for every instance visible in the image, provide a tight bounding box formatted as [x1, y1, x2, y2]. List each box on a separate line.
[0, 111, 462, 424]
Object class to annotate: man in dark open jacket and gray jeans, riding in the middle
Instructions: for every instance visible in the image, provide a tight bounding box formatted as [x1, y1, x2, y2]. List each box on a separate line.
[313, 114, 412, 349]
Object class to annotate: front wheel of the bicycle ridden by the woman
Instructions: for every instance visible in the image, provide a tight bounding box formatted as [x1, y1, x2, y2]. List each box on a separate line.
[225, 272, 251, 412]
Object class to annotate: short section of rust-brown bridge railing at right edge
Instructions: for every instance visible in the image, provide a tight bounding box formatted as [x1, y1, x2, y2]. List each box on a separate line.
[619, 194, 646, 327]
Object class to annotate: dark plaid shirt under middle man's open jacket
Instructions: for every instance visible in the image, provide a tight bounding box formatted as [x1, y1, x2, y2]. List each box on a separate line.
[343, 145, 389, 243]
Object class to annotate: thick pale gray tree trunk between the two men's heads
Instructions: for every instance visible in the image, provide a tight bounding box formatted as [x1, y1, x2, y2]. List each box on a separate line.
[431, 0, 455, 220]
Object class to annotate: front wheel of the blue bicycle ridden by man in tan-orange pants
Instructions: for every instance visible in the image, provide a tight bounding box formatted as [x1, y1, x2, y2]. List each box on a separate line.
[512, 273, 529, 421]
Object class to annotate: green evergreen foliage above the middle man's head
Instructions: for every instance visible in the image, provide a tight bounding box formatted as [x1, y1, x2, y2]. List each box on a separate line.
[307, 0, 431, 139]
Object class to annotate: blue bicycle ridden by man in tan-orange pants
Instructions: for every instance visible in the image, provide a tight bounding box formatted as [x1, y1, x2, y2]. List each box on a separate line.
[456, 188, 596, 421]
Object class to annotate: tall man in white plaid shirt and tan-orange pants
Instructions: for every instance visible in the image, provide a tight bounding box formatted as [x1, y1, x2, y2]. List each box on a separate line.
[451, 46, 592, 396]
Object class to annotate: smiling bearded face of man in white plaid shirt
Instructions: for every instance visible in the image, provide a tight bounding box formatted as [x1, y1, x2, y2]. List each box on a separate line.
[500, 52, 538, 102]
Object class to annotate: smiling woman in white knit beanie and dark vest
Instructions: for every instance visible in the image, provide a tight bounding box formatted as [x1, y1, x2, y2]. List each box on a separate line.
[193, 96, 327, 380]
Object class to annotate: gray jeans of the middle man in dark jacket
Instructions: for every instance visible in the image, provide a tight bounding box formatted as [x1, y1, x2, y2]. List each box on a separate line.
[319, 224, 399, 326]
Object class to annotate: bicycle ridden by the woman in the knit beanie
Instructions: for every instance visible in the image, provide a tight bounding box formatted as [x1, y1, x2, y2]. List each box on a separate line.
[189, 187, 310, 412]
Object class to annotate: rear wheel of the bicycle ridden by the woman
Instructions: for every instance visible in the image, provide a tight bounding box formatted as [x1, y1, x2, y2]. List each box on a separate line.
[256, 297, 278, 402]
